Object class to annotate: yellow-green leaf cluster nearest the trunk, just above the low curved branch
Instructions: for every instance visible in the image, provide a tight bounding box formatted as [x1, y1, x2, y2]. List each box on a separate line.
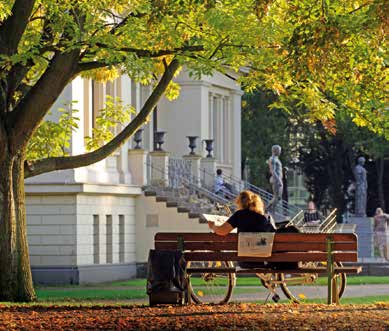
[27, 101, 79, 160]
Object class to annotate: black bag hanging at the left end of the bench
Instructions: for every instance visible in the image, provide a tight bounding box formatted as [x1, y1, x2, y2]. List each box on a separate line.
[146, 249, 187, 306]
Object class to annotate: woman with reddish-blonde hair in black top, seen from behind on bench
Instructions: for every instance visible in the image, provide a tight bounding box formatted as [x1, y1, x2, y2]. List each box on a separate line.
[208, 191, 275, 236]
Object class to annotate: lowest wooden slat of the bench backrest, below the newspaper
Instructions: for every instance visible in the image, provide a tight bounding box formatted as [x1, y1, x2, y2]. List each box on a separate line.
[184, 252, 358, 262]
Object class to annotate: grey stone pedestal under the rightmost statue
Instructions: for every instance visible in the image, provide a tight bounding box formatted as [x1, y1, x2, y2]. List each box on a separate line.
[347, 216, 374, 259]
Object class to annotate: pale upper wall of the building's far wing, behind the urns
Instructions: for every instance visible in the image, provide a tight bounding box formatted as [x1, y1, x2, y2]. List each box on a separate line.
[158, 71, 243, 178]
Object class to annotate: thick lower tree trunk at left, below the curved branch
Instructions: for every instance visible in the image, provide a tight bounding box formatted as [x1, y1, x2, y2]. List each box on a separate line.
[0, 155, 36, 302]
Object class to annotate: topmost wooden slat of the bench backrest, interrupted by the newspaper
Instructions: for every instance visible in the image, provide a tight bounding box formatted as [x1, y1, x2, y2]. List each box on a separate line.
[154, 232, 357, 242]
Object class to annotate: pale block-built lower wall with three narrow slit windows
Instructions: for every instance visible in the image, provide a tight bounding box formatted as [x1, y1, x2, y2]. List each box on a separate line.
[26, 185, 140, 266]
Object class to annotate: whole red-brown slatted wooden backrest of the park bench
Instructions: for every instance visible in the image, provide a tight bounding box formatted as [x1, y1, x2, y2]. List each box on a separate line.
[154, 232, 358, 262]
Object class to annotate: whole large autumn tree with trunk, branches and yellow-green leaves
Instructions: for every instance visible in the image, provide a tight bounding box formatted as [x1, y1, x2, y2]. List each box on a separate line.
[0, 0, 389, 300]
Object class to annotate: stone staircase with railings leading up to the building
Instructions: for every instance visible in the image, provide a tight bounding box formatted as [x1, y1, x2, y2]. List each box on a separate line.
[143, 158, 302, 223]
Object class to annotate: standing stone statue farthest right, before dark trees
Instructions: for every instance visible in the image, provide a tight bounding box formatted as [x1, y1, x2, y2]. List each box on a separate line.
[354, 156, 367, 217]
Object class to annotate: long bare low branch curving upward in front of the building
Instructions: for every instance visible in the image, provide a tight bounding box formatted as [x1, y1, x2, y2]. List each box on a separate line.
[25, 59, 179, 178]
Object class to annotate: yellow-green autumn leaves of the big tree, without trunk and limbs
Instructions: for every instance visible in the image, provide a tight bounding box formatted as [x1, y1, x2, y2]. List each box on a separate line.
[0, 0, 389, 159]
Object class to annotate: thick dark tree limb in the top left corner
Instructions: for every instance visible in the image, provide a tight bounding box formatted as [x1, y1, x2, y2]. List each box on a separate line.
[0, 0, 35, 55]
